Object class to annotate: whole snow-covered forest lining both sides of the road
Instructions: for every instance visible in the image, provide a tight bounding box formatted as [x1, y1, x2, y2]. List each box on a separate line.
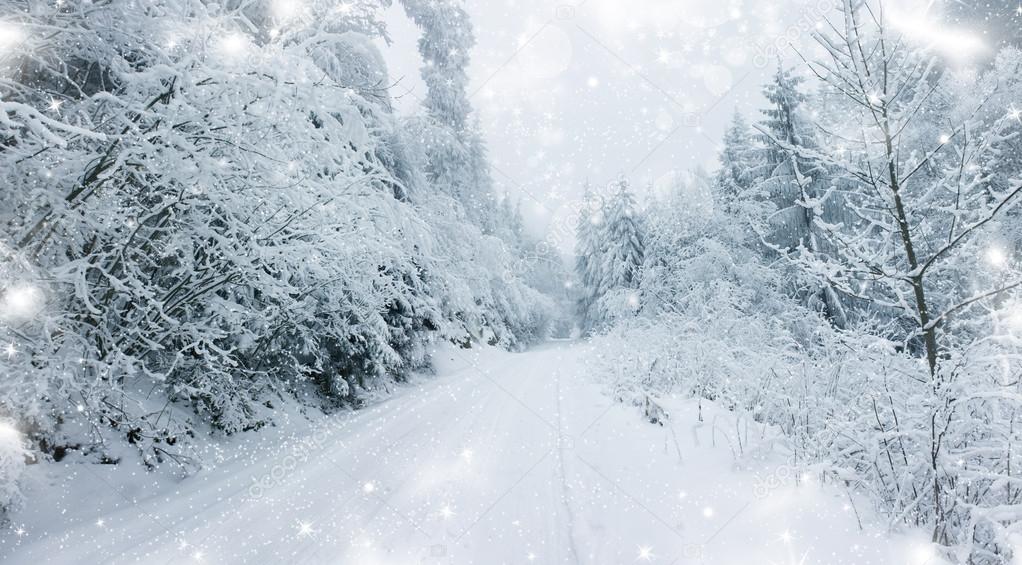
[0, 0, 1022, 565]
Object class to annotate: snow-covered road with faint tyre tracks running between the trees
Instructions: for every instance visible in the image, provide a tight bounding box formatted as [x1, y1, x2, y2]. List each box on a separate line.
[0, 343, 937, 565]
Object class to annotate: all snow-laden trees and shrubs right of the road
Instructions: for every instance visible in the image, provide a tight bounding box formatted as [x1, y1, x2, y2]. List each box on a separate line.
[598, 0, 1022, 564]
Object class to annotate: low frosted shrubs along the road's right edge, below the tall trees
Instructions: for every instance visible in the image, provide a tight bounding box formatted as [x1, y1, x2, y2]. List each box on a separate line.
[596, 192, 1022, 560]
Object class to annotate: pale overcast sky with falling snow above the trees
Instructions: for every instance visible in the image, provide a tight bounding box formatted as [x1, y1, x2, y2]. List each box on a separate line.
[384, 0, 1019, 246]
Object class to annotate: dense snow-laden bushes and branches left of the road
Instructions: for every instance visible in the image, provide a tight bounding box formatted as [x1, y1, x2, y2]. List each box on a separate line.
[0, 0, 549, 484]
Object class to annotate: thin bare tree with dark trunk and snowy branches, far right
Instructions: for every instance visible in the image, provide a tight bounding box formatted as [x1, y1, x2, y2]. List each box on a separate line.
[771, 0, 1022, 562]
